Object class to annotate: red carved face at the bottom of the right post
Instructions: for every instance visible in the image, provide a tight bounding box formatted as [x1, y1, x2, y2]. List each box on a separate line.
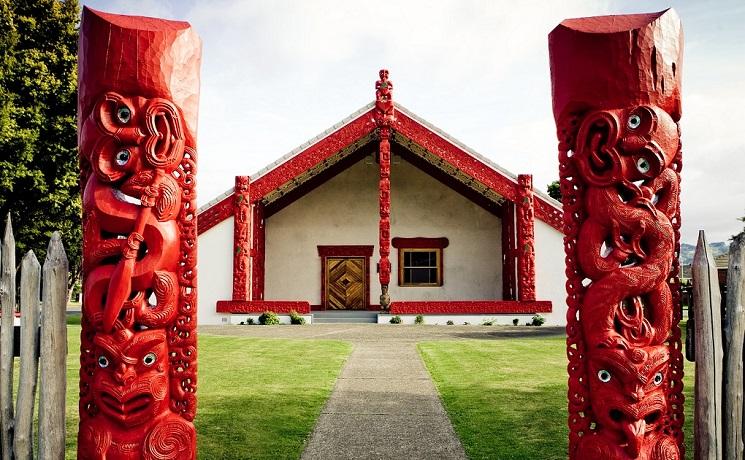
[588, 345, 670, 458]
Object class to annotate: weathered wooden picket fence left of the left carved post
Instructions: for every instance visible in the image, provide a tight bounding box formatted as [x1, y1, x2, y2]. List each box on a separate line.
[0, 217, 68, 460]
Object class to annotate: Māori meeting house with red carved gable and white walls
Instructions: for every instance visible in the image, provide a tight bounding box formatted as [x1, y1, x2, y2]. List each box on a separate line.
[198, 70, 566, 325]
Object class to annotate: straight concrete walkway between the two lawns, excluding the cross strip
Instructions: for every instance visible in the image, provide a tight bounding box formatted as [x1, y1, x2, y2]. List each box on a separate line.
[301, 342, 466, 460]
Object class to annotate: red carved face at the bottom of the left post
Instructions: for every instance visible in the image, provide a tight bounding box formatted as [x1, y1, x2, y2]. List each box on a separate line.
[91, 329, 168, 427]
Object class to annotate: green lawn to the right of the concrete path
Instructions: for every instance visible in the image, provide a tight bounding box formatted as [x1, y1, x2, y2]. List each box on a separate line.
[419, 337, 693, 460]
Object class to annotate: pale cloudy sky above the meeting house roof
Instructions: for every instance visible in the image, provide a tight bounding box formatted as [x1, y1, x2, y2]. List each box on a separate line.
[82, 0, 745, 244]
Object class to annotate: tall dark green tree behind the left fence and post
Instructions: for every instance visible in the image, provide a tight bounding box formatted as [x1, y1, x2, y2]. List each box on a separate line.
[0, 0, 82, 294]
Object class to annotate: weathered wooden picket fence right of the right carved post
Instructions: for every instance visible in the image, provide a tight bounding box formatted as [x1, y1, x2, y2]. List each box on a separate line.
[692, 231, 745, 460]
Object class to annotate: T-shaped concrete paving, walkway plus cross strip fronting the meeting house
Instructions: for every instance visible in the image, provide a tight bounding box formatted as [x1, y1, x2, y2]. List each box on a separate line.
[199, 324, 564, 460]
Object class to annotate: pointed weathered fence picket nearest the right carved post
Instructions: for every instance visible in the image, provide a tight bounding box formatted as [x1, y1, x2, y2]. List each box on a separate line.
[691, 231, 722, 460]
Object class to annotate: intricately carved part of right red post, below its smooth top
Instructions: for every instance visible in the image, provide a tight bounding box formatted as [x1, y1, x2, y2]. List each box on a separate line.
[560, 105, 679, 459]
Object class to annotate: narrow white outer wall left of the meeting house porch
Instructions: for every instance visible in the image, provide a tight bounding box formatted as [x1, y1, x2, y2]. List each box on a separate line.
[197, 217, 233, 324]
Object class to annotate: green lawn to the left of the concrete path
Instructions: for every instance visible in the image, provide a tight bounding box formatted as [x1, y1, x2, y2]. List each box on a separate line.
[55, 325, 352, 460]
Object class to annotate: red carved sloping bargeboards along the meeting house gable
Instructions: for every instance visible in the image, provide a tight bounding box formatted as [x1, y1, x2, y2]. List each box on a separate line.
[198, 108, 563, 234]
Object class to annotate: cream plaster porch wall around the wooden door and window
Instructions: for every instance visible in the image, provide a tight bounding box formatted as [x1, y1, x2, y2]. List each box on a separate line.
[265, 158, 502, 305]
